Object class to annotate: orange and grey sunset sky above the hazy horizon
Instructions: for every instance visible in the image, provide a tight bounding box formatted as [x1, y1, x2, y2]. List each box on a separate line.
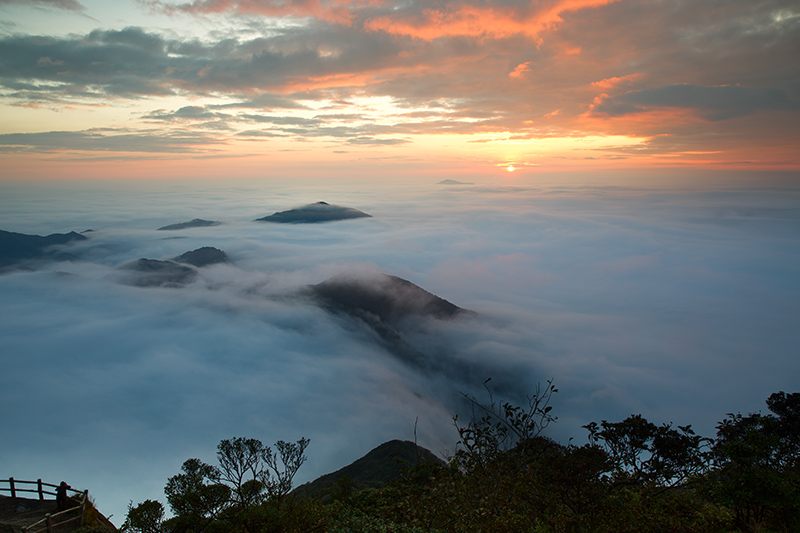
[0, 0, 800, 179]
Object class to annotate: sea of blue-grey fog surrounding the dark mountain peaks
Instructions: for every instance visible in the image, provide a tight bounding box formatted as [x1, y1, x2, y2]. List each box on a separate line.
[0, 175, 800, 524]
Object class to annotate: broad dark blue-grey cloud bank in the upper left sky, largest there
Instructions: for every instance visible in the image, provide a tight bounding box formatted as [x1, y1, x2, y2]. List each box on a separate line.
[0, 22, 406, 101]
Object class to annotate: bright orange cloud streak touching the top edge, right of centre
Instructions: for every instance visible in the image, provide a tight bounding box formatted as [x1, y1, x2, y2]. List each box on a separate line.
[364, 0, 618, 41]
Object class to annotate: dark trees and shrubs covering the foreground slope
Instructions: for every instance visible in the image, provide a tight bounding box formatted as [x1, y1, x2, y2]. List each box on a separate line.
[123, 382, 800, 533]
